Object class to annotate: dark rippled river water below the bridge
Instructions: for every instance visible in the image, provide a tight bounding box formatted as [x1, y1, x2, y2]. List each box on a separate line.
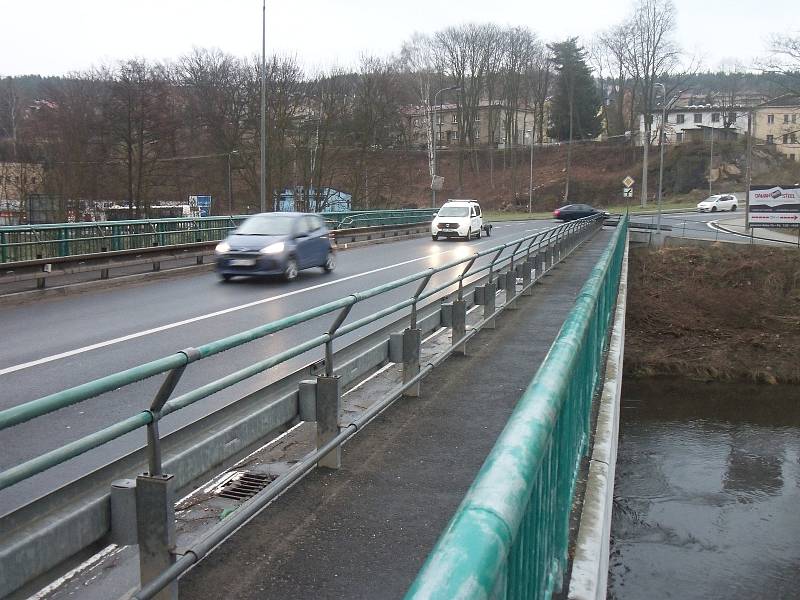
[608, 381, 800, 600]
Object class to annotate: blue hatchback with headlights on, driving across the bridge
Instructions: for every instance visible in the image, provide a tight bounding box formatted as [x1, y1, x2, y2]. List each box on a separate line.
[216, 213, 336, 281]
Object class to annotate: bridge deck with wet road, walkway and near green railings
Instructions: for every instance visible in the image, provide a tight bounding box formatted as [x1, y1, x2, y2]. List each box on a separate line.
[0, 210, 628, 598]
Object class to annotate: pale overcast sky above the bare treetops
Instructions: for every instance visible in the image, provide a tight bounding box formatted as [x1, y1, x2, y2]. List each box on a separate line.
[0, 0, 797, 75]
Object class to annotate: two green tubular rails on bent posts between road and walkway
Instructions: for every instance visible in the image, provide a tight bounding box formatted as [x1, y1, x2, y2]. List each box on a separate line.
[0, 217, 598, 490]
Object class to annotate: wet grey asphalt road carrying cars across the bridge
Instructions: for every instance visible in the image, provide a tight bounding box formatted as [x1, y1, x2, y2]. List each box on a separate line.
[0, 221, 555, 514]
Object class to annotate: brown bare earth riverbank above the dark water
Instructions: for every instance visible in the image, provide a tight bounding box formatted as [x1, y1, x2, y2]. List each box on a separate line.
[625, 244, 800, 384]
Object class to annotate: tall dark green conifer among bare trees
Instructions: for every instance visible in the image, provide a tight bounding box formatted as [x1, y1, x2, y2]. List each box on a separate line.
[547, 38, 600, 140]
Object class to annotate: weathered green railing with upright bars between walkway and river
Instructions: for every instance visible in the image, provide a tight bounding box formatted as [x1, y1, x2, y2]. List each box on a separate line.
[406, 217, 628, 600]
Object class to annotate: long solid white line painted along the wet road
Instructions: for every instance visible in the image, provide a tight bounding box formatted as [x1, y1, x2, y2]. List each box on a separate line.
[0, 230, 531, 375]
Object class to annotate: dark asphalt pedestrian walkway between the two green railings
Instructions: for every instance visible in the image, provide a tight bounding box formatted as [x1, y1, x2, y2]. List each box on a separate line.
[180, 230, 613, 600]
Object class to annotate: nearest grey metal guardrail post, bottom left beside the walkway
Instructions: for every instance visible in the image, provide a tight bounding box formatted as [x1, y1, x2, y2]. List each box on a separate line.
[136, 473, 178, 600]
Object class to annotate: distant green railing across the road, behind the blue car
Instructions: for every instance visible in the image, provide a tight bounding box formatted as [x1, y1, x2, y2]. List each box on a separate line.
[0, 208, 436, 263]
